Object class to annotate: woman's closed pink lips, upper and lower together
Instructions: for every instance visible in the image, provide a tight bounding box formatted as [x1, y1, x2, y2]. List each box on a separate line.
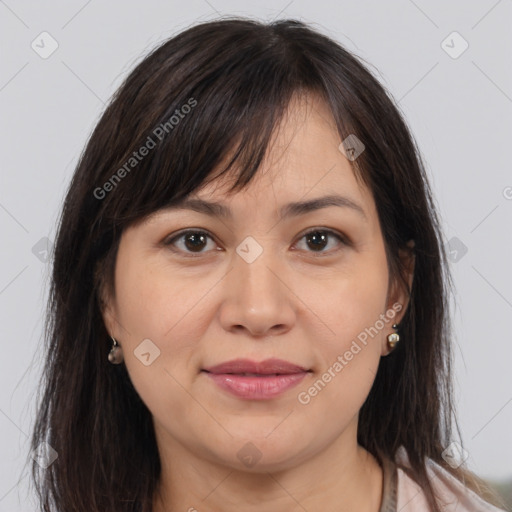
[202, 359, 308, 400]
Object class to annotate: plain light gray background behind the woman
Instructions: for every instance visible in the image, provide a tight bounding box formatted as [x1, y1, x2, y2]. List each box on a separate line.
[0, 0, 512, 512]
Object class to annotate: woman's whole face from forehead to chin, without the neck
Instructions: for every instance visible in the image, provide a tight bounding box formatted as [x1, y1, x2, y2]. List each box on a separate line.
[104, 96, 407, 471]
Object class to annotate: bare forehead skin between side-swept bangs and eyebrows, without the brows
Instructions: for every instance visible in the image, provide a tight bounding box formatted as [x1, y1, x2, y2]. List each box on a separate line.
[189, 95, 375, 216]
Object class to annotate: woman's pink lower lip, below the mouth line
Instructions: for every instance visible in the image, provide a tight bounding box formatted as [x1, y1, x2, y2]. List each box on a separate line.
[205, 372, 307, 400]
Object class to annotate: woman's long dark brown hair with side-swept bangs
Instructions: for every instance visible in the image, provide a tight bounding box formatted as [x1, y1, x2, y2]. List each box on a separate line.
[31, 18, 504, 512]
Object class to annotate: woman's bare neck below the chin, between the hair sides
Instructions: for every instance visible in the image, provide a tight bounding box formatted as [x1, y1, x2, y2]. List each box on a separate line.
[153, 422, 383, 512]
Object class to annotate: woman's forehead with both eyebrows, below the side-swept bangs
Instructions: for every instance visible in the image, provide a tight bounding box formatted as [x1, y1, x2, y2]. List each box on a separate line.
[137, 94, 380, 232]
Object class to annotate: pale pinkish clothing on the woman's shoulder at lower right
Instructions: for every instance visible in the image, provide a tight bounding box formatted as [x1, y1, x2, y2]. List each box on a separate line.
[379, 447, 505, 512]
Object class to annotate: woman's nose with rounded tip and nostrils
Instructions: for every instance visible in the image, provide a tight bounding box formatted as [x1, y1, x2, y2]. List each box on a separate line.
[220, 246, 297, 337]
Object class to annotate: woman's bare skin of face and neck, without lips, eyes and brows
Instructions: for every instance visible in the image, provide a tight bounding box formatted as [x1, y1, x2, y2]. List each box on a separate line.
[104, 95, 413, 512]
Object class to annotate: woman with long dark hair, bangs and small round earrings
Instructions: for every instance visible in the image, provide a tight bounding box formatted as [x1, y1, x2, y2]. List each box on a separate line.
[32, 19, 508, 512]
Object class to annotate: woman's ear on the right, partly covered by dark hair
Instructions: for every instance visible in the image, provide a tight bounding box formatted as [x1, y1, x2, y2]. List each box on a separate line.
[381, 240, 415, 356]
